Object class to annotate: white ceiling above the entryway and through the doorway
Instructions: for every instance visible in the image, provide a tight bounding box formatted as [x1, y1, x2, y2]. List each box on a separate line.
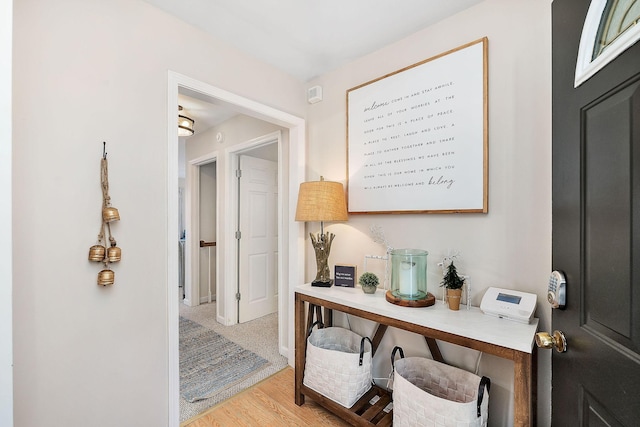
[165, 0, 483, 132]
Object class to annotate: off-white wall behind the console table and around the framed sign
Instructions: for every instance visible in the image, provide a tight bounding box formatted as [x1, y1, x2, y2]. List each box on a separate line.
[306, 0, 551, 426]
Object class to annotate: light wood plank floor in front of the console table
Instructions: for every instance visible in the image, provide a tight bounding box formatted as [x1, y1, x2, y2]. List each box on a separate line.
[181, 367, 350, 427]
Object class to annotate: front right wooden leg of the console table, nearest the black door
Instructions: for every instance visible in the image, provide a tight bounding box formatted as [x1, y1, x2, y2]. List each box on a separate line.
[513, 351, 534, 427]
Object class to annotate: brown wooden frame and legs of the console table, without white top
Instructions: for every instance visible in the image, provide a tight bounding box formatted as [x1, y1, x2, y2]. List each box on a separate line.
[294, 291, 537, 427]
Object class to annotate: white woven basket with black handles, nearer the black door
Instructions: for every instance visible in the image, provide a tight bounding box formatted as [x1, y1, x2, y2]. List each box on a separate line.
[393, 357, 490, 427]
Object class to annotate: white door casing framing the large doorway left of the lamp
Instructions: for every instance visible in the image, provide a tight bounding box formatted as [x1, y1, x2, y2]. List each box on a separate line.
[167, 71, 306, 427]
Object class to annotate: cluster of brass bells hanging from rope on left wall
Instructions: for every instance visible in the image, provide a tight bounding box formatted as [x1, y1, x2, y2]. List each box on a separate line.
[89, 142, 122, 286]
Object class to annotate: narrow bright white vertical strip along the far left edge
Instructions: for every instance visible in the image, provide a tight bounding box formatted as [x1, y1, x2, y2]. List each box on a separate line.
[0, 0, 13, 427]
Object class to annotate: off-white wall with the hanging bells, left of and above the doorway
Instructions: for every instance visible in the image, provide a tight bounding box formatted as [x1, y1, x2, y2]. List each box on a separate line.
[12, 0, 306, 427]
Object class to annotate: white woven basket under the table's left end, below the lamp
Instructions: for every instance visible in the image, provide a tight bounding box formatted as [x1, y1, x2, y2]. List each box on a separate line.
[302, 328, 372, 408]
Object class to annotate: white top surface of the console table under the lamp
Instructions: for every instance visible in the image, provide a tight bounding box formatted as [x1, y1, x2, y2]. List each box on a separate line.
[295, 284, 538, 353]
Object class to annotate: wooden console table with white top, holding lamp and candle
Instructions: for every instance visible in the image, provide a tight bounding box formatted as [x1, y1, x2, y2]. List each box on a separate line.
[294, 284, 538, 426]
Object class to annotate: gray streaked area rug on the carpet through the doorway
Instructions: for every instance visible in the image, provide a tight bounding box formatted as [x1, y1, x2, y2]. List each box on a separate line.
[180, 317, 269, 402]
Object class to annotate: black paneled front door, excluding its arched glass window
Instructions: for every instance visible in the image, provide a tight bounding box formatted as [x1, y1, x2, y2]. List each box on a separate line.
[552, 0, 640, 427]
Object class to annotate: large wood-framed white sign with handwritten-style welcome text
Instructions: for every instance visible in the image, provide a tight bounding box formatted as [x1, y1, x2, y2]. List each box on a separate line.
[347, 37, 488, 214]
